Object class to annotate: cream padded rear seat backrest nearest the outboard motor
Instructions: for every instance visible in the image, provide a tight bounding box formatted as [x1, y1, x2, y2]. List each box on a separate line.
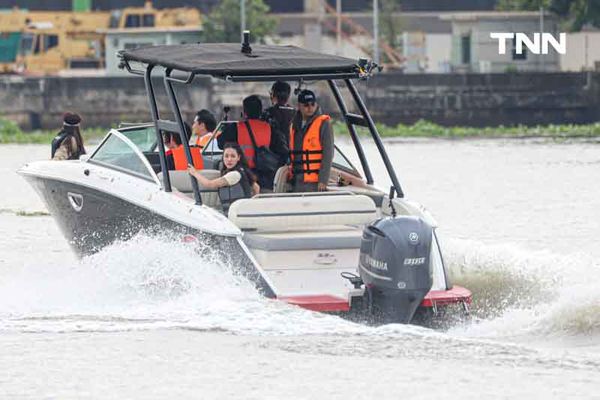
[229, 192, 377, 232]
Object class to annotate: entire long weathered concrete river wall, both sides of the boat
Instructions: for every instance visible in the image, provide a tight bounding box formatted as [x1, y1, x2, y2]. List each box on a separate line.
[0, 72, 600, 129]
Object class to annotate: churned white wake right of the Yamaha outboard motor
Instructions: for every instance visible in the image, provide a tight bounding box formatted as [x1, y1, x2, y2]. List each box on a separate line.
[445, 240, 600, 340]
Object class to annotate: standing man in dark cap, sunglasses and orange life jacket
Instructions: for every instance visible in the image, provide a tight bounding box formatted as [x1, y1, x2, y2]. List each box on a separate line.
[289, 90, 334, 192]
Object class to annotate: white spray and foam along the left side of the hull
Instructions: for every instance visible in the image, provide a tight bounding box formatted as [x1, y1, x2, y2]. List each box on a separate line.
[0, 235, 394, 335]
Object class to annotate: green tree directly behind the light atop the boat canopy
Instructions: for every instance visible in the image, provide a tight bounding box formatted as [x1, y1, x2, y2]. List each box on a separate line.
[203, 0, 277, 43]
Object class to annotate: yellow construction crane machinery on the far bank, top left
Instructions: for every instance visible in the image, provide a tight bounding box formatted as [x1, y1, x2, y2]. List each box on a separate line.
[0, 2, 201, 74]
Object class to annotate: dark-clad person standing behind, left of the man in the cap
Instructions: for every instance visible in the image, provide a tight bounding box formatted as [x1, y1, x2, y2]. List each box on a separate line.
[263, 81, 296, 148]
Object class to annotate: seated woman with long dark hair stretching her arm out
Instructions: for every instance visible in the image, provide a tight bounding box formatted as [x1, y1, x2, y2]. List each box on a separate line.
[188, 142, 260, 214]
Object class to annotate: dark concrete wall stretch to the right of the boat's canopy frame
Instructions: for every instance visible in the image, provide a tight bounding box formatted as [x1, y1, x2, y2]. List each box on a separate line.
[365, 73, 600, 126]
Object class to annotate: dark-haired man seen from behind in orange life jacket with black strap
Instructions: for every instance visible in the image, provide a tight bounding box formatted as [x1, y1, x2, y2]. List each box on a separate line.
[217, 95, 288, 191]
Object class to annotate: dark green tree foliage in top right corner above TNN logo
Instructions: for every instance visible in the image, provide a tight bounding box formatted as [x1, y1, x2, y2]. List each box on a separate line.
[496, 0, 600, 31]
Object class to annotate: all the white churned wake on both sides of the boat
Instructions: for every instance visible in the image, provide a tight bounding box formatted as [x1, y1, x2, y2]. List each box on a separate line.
[0, 235, 600, 339]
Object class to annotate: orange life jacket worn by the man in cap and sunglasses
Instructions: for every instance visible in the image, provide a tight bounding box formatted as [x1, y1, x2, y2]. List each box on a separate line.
[290, 115, 331, 183]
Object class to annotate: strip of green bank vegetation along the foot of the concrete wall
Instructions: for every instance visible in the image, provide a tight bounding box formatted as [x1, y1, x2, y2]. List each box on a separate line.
[0, 119, 600, 144]
